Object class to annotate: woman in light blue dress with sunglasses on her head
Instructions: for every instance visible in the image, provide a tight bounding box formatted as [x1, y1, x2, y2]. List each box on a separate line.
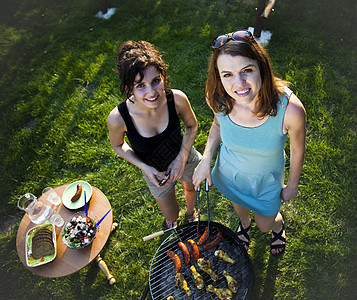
[193, 30, 306, 255]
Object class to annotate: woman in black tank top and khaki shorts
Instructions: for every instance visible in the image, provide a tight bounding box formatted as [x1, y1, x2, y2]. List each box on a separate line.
[107, 41, 201, 228]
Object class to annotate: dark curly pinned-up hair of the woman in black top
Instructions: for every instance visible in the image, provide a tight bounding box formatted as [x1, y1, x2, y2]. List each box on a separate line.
[117, 41, 169, 98]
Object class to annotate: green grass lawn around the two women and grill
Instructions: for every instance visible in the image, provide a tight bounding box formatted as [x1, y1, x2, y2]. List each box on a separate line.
[0, 0, 357, 300]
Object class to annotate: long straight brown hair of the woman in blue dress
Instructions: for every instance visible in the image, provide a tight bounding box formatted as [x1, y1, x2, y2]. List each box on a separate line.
[206, 37, 289, 118]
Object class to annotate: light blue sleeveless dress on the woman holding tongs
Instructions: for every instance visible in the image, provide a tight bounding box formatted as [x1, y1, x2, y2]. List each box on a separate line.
[212, 88, 292, 216]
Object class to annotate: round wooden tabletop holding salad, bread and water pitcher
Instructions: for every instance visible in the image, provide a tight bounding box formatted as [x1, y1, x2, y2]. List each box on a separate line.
[16, 184, 113, 278]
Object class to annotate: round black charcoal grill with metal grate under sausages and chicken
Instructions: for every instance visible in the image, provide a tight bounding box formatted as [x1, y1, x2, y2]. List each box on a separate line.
[142, 221, 254, 300]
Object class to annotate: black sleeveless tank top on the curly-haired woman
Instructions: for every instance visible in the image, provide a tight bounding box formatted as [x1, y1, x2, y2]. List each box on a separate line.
[118, 90, 182, 172]
